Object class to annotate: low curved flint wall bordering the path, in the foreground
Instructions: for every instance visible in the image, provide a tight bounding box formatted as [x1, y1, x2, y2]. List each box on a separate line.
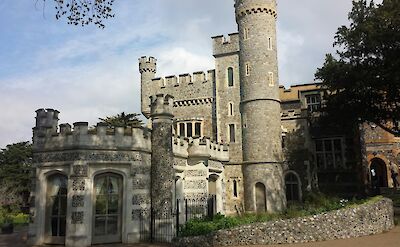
[174, 198, 394, 247]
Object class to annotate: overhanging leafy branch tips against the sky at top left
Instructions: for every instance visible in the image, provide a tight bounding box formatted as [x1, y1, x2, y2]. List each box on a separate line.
[35, 0, 115, 28]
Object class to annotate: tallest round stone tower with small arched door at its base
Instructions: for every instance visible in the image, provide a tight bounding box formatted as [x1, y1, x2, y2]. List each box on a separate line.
[235, 0, 286, 212]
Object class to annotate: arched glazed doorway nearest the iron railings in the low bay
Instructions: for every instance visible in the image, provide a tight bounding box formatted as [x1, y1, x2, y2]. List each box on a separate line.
[92, 173, 122, 244]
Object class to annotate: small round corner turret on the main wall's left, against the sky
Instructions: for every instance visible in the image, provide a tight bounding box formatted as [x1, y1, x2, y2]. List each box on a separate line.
[139, 56, 157, 118]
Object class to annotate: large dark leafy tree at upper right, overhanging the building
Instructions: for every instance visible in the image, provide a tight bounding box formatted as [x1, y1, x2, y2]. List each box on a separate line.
[315, 0, 400, 135]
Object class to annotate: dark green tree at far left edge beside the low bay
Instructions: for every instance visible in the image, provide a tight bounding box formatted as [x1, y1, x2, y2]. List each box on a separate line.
[0, 142, 32, 205]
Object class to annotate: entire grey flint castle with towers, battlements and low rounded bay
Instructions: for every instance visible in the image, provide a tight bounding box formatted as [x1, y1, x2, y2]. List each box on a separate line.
[29, 0, 400, 246]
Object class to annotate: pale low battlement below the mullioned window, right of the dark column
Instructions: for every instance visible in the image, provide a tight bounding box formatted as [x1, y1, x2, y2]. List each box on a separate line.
[172, 135, 229, 162]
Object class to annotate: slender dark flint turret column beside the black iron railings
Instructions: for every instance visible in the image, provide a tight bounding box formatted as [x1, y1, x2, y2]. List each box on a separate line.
[150, 94, 175, 216]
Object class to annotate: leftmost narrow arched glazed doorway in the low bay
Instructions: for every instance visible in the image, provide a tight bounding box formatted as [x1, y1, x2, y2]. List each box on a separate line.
[45, 174, 68, 244]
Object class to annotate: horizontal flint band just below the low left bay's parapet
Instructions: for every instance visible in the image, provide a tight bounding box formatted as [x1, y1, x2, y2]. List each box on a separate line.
[34, 151, 142, 163]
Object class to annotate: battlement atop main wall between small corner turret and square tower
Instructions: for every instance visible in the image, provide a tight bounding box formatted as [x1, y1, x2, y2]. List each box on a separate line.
[152, 70, 215, 89]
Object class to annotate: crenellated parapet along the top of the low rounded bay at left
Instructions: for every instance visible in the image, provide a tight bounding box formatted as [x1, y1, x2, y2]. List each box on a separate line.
[33, 118, 151, 153]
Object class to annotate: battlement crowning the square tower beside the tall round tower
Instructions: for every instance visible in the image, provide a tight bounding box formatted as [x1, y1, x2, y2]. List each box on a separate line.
[212, 33, 240, 57]
